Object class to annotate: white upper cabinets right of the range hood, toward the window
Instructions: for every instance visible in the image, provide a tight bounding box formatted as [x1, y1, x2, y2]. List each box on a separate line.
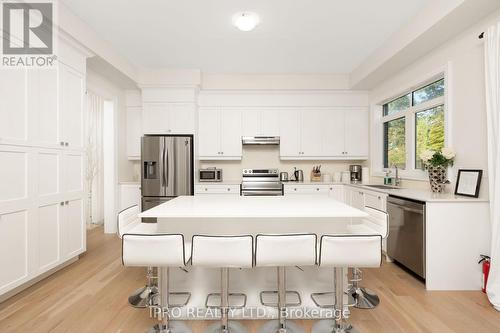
[280, 108, 368, 159]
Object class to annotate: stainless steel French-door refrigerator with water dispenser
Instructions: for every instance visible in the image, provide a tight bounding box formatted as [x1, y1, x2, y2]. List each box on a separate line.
[141, 135, 194, 222]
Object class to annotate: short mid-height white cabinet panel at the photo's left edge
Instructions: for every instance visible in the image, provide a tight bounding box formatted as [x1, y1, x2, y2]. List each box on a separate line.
[0, 146, 28, 201]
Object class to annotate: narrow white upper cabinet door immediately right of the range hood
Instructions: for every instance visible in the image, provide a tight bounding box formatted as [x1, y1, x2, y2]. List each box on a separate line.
[280, 110, 301, 157]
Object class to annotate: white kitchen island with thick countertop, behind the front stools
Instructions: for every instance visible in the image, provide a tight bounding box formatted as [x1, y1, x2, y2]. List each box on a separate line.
[140, 195, 368, 319]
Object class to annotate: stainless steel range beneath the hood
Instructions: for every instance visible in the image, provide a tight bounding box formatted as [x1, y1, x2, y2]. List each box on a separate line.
[241, 169, 283, 196]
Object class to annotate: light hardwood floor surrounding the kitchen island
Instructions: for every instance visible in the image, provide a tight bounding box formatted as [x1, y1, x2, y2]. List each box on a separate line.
[0, 228, 500, 333]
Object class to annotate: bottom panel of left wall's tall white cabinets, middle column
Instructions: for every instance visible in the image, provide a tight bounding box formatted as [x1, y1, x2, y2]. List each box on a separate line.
[37, 202, 63, 271]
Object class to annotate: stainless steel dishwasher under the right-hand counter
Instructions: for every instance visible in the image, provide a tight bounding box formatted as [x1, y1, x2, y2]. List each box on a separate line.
[387, 196, 425, 279]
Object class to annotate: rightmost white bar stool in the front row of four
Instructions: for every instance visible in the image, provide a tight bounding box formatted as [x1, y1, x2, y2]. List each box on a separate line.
[311, 235, 382, 333]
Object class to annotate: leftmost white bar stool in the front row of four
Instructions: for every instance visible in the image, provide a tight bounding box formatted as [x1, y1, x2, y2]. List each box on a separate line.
[122, 233, 191, 333]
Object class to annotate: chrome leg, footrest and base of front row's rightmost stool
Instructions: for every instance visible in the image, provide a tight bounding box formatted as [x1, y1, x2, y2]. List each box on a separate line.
[311, 268, 358, 333]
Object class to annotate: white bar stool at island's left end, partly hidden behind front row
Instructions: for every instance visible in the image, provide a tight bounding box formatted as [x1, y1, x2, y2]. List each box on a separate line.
[116, 205, 158, 308]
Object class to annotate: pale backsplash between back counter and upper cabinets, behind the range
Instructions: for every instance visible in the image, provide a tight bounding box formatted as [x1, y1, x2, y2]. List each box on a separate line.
[197, 146, 368, 182]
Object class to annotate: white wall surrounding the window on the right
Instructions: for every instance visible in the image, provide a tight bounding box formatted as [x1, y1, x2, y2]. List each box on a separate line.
[370, 7, 500, 195]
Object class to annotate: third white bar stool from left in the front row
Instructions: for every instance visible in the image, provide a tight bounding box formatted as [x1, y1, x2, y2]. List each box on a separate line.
[255, 234, 317, 333]
